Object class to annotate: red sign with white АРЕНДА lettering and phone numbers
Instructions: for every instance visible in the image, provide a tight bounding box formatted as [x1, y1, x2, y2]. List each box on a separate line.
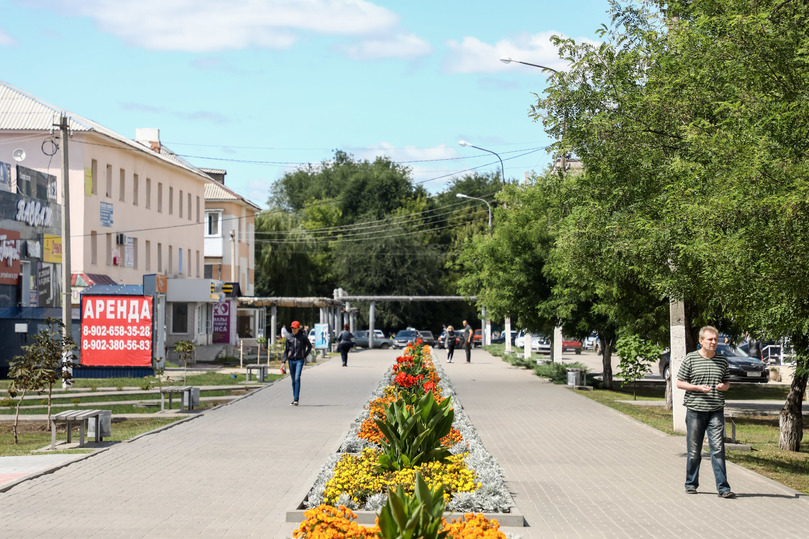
[81, 296, 152, 367]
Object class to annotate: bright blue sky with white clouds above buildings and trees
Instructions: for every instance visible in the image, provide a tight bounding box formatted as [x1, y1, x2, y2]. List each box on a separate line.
[0, 0, 609, 207]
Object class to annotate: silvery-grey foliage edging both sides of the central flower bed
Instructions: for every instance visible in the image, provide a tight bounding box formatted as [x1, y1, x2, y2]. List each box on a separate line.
[286, 354, 525, 527]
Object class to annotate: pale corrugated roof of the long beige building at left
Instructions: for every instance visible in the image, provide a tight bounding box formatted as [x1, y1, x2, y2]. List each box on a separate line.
[0, 80, 210, 180]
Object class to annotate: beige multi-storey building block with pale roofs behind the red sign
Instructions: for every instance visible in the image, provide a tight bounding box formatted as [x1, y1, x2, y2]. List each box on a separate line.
[0, 81, 258, 357]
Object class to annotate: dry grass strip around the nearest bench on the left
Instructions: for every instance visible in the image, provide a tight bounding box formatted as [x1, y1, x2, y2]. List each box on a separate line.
[0, 417, 182, 457]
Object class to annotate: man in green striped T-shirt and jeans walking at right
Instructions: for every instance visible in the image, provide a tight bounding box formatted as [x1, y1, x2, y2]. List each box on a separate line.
[677, 326, 736, 498]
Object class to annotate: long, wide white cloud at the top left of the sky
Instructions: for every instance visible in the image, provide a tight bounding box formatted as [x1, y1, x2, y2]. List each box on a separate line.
[33, 0, 399, 52]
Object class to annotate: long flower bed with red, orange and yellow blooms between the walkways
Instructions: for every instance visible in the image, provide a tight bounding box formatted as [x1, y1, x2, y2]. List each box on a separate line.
[288, 346, 524, 537]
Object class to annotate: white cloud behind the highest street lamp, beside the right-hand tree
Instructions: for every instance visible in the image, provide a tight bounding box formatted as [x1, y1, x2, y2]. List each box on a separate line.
[444, 31, 595, 74]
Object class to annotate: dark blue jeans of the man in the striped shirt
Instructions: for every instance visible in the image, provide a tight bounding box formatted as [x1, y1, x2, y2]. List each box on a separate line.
[685, 409, 730, 493]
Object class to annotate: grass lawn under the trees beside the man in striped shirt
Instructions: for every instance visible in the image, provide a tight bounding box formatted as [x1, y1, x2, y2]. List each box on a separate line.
[580, 384, 809, 494]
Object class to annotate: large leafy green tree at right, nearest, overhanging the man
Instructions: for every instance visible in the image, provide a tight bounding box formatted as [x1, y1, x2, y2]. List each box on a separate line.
[534, 0, 809, 450]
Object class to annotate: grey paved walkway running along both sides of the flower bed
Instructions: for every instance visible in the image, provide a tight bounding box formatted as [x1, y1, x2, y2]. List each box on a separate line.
[0, 350, 809, 539]
